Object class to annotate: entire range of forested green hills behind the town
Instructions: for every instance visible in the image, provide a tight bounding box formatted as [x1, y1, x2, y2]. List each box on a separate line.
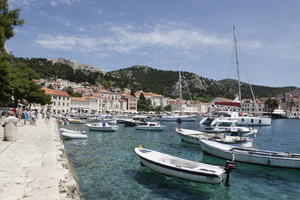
[17, 58, 295, 101]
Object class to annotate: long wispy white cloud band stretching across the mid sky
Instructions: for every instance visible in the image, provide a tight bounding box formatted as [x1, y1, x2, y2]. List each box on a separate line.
[35, 23, 262, 54]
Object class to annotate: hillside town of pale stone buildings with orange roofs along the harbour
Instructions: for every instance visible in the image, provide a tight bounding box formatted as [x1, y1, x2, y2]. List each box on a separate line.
[34, 79, 300, 118]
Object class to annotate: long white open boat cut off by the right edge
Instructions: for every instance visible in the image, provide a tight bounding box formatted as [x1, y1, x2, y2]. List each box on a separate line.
[199, 139, 300, 169]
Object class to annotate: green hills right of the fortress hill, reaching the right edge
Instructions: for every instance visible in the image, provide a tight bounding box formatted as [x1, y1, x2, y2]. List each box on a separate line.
[105, 66, 296, 101]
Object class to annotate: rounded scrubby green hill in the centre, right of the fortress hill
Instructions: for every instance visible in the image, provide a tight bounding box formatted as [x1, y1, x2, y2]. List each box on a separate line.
[106, 66, 234, 101]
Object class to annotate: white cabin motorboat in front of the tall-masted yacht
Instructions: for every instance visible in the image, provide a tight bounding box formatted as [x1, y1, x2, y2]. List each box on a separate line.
[204, 118, 258, 135]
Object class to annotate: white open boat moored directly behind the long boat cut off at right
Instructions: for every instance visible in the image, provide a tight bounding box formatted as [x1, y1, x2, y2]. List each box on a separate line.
[175, 128, 253, 147]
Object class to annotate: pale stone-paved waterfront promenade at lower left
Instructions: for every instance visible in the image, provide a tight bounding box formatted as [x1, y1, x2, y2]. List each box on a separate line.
[0, 119, 80, 200]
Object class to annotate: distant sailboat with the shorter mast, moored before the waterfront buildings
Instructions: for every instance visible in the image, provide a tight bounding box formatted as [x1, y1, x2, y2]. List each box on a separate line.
[160, 70, 197, 122]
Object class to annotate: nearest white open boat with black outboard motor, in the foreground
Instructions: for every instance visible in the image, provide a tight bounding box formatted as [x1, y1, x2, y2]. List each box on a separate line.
[134, 147, 237, 184]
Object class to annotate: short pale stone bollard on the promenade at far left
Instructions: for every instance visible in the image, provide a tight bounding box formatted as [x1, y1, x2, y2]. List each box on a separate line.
[4, 116, 18, 141]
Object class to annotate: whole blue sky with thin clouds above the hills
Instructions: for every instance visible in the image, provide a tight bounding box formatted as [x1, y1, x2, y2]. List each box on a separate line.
[7, 0, 300, 87]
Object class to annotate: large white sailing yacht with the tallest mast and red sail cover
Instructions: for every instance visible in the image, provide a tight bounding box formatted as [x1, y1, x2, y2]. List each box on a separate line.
[211, 25, 271, 126]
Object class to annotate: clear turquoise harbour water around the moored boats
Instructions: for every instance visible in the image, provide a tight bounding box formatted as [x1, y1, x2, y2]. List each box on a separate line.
[65, 120, 300, 200]
